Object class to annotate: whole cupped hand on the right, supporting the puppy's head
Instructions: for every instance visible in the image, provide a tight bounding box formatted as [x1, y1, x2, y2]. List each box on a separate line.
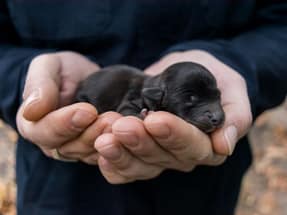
[95, 51, 252, 184]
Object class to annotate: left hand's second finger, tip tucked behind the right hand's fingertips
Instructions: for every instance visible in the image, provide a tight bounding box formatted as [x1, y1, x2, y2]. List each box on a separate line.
[58, 112, 121, 159]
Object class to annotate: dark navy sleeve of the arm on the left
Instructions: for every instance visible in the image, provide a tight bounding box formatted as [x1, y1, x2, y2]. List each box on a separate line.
[0, 1, 47, 128]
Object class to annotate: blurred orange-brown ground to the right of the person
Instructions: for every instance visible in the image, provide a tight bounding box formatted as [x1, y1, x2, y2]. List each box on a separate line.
[236, 103, 287, 215]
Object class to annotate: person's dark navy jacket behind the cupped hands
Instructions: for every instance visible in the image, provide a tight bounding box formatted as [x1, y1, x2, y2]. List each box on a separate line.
[0, 0, 287, 215]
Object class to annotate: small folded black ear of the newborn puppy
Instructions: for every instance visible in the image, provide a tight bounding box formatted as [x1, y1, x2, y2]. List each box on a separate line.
[141, 87, 164, 110]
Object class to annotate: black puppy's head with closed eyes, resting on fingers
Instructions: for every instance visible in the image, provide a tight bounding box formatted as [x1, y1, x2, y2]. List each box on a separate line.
[142, 62, 224, 133]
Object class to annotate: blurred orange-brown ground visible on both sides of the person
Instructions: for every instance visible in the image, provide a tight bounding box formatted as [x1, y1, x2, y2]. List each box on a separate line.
[0, 102, 287, 215]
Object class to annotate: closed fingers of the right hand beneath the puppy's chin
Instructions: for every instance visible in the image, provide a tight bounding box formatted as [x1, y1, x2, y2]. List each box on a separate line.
[95, 111, 225, 184]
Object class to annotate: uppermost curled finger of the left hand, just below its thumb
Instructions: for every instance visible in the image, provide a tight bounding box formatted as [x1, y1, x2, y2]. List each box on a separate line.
[17, 103, 97, 148]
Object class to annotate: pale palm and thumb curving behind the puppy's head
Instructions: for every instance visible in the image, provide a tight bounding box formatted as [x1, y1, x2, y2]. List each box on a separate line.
[145, 50, 252, 155]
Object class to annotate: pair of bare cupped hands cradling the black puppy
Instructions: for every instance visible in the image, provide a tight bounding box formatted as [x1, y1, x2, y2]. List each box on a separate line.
[17, 50, 252, 184]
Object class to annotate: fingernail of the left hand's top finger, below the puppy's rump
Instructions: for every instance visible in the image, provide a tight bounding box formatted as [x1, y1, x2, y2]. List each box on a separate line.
[71, 110, 95, 129]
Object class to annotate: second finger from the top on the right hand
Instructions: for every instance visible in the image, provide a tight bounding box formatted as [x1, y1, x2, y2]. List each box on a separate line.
[112, 116, 177, 167]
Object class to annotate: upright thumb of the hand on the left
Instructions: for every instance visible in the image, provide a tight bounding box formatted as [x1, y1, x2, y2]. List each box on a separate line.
[23, 54, 61, 121]
